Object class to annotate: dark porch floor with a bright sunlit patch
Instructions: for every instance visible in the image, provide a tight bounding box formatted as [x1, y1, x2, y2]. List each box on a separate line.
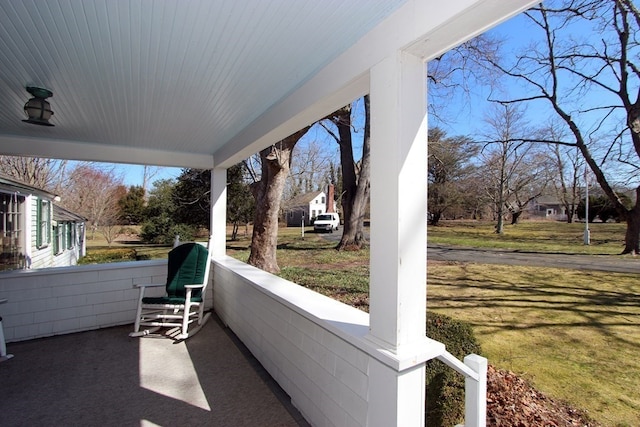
[0, 314, 308, 427]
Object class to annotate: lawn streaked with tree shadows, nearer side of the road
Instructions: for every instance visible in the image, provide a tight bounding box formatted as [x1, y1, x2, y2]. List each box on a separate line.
[428, 262, 640, 426]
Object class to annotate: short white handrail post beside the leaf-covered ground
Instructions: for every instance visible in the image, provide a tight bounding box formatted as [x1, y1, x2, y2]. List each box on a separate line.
[464, 354, 487, 427]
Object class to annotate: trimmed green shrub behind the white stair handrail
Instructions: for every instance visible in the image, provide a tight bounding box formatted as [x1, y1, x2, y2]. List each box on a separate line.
[425, 312, 480, 427]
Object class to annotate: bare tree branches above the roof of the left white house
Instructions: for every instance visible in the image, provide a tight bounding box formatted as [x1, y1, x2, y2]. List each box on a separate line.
[0, 156, 68, 194]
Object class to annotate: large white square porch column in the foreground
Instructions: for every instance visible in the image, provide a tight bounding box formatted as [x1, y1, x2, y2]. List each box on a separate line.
[368, 52, 427, 427]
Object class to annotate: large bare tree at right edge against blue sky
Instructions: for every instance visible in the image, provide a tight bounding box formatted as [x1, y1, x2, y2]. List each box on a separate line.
[487, 0, 640, 254]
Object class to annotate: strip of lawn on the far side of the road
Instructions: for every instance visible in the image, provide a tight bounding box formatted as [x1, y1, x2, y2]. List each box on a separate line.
[429, 221, 626, 255]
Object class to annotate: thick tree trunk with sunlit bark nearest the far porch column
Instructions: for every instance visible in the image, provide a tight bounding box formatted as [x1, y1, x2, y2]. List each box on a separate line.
[247, 127, 309, 273]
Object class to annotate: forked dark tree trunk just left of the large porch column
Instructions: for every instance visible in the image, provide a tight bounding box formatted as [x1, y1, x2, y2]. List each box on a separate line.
[334, 95, 371, 250]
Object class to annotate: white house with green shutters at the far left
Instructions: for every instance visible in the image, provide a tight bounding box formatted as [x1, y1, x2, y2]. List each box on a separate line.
[0, 177, 86, 271]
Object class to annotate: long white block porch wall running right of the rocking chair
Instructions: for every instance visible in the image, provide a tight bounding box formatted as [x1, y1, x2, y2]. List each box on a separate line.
[213, 257, 462, 426]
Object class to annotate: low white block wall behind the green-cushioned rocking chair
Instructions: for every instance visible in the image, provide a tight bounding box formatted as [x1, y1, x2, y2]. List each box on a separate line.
[0, 260, 212, 342]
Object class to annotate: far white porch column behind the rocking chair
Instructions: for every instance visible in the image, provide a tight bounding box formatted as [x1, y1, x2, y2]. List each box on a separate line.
[209, 168, 227, 257]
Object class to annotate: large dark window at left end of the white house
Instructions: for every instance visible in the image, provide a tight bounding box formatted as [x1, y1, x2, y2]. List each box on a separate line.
[0, 193, 25, 270]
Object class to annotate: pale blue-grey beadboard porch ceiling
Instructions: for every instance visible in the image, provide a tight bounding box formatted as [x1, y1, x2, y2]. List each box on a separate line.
[0, 0, 532, 171]
